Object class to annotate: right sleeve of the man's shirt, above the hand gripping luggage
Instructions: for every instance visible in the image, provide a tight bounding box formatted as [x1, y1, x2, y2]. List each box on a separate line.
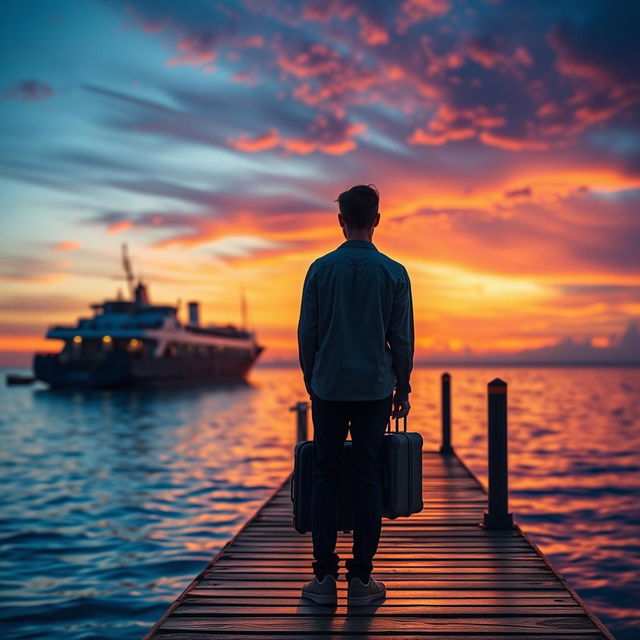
[387, 268, 414, 396]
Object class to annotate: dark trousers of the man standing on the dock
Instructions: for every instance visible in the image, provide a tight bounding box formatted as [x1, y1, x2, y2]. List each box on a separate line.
[311, 394, 391, 582]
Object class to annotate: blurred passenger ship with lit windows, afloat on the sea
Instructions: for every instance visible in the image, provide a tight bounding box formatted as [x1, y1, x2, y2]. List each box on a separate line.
[33, 245, 264, 389]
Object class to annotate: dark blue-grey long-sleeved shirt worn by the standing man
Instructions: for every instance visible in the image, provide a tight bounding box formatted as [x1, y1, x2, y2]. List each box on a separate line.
[298, 240, 414, 400]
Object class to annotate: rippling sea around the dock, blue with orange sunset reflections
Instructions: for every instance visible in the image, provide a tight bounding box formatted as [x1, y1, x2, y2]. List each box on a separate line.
[0, 368, 640, 640]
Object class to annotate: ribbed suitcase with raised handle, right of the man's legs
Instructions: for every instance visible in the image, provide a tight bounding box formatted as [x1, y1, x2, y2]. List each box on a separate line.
[382, 416, 423, 519]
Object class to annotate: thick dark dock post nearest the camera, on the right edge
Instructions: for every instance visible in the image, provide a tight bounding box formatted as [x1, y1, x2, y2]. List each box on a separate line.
[482, 378, 513, 529]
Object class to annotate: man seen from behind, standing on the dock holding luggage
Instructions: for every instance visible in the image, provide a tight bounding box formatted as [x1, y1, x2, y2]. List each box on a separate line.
[298, 185, 414, 605]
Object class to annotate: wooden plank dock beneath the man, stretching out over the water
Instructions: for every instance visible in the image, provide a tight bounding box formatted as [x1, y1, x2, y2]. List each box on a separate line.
[146, 452, 613, 640]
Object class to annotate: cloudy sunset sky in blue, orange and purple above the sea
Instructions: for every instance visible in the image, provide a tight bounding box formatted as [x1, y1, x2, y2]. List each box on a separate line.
[0, 0, 640, 363]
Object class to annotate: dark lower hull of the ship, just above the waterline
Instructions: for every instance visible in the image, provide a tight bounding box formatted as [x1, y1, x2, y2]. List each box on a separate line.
[33, 347, 262, 389]
